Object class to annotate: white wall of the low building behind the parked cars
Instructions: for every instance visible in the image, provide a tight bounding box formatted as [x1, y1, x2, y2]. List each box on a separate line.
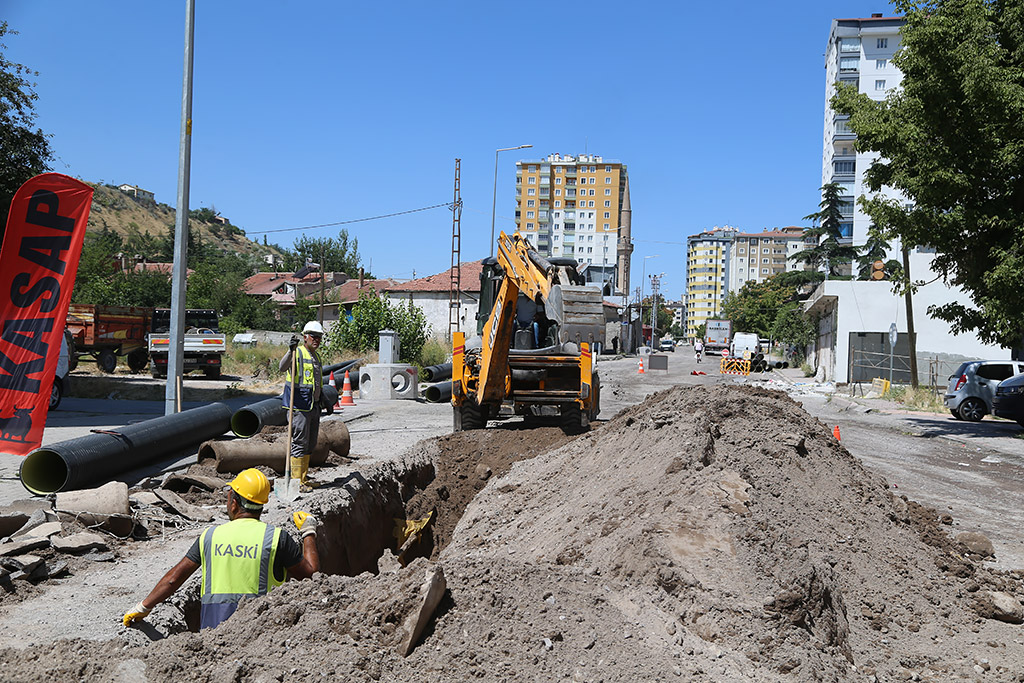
[807, 278, 1010, 383]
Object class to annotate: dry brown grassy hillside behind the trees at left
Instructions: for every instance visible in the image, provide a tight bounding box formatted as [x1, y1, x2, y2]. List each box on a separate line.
[87, 182, 280, 259]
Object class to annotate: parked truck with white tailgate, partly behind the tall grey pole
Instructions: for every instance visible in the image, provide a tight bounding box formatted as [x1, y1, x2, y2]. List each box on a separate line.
[148, 308, 227, 380]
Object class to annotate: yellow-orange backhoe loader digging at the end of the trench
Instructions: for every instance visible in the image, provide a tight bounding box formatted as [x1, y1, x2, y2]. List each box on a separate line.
[452, 232, 604, 432]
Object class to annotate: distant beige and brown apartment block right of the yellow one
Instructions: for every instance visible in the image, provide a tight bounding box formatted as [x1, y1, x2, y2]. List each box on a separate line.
[726, 225, 814, 292]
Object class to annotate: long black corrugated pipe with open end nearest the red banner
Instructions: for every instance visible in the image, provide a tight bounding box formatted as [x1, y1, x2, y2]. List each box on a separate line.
[18, 403, 231, 496]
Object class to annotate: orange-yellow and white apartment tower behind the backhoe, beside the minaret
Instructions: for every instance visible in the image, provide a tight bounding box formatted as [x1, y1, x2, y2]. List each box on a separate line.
[515, 155, 633, 293]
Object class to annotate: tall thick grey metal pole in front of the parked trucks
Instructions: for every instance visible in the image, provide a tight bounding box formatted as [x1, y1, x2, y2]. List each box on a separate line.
[164, 0, 196, 415]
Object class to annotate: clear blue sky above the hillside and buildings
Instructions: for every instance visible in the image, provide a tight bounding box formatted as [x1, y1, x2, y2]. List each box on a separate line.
[0, 0, 893, 298]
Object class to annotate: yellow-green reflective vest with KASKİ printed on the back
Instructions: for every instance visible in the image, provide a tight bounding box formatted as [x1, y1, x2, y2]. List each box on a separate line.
[199, 517, 285, 629]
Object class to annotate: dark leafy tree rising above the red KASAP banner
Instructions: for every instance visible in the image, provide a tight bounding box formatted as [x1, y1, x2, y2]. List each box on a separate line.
[0, 22, 53, 232]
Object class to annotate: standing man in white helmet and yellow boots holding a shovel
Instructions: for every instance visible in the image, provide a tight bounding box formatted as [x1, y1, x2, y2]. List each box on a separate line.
[279, 321, 334, 488]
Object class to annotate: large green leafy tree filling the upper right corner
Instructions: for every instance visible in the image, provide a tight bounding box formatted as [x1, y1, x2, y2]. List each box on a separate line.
[833, 0, 1024, 346]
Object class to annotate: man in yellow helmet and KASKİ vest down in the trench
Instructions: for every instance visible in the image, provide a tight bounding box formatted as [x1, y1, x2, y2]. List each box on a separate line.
[122, 468, 319, 629]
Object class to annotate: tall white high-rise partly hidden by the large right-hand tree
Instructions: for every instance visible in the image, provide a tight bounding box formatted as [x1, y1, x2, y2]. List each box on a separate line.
[821, 14, 905, 246]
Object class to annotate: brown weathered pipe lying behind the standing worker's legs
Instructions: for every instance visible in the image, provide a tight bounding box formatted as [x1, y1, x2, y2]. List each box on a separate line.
[199, 420, 351, 474]
